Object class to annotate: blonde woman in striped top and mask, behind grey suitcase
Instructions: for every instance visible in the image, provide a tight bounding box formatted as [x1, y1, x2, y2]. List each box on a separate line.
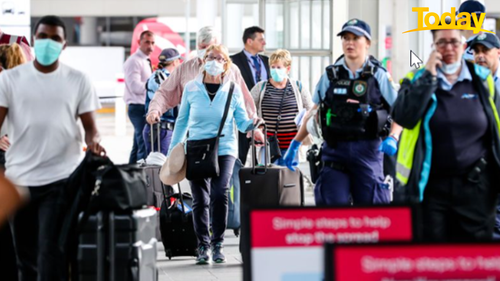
[251, 49, 313, 166]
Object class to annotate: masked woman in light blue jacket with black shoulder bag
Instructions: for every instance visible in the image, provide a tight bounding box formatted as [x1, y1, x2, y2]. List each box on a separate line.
[169, 45, 260, 264]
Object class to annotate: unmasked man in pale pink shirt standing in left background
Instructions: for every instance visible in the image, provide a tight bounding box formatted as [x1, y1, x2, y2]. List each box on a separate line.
[123, 30, 155, 164]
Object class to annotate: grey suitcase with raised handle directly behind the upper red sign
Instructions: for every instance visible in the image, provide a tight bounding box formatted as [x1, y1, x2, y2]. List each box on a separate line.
[240, 124, 304, 207]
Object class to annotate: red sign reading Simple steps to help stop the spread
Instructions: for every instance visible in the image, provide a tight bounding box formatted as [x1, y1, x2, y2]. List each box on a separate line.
[250, 207, 413, 249]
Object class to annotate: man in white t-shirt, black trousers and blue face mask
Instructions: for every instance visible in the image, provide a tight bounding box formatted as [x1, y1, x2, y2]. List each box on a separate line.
[0, 16, 105, 281]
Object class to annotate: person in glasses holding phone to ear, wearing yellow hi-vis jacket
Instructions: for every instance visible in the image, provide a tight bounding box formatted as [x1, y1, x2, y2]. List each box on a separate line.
[393, 23, 500, 241]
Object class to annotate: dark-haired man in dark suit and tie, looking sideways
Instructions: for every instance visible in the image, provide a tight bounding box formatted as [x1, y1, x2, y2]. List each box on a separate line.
[231, 26, 270, 165]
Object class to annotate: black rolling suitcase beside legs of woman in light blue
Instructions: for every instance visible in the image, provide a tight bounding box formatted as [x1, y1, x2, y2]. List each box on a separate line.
[160, 184, 198, 259]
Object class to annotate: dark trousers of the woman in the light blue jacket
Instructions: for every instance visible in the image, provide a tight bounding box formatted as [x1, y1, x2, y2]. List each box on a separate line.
[189, 155, 236, 247]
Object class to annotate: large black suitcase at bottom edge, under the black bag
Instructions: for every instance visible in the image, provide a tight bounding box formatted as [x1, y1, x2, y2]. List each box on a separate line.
[76, 209, 158, 281]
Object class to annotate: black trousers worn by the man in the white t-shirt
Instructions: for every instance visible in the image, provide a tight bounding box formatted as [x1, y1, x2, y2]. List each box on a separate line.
[13, 180, 66, 281]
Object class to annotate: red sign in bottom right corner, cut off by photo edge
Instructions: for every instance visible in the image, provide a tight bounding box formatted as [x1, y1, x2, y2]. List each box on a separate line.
[325, 244, 500, 281]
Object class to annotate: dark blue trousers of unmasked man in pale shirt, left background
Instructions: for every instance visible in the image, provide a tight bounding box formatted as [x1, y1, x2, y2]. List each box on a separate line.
[128, 104, 147, 164]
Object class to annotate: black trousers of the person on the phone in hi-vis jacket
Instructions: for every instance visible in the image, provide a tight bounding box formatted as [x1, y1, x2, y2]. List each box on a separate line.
[422, 169, 498, 242]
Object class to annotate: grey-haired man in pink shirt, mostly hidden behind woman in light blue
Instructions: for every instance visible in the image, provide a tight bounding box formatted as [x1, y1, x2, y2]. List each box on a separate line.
[146, 26, 264, 145]
